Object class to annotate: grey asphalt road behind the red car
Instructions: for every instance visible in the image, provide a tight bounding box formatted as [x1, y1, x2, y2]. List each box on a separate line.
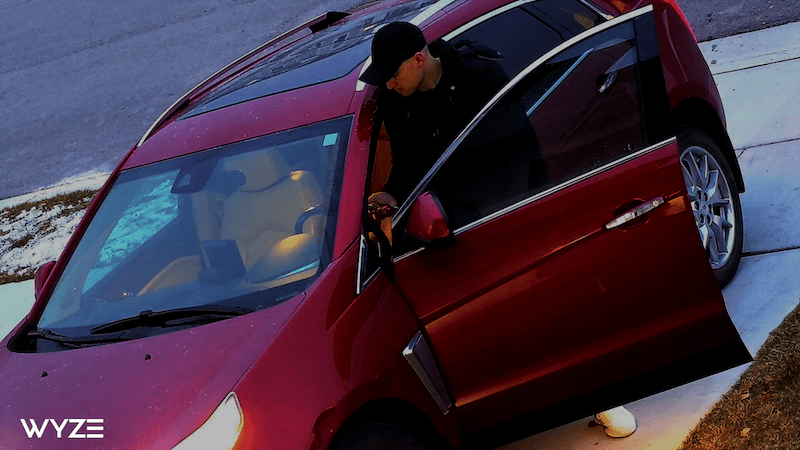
[0, 0, 800, 198]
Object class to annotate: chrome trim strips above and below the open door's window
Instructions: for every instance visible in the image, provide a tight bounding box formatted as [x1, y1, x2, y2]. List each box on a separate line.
[392, 6, 660, 231]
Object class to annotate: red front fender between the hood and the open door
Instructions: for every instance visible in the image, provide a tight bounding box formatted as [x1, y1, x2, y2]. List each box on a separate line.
[228, 245, 458, 449]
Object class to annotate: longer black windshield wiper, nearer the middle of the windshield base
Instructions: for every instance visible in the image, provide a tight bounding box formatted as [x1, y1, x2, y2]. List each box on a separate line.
[89, 305, 253, 334]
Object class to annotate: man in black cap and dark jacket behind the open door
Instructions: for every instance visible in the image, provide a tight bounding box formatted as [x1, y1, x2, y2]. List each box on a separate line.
[359, 22, 636, 437]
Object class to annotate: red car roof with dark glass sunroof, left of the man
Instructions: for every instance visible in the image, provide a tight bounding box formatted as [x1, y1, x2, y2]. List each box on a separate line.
[124, 0, 457, 168]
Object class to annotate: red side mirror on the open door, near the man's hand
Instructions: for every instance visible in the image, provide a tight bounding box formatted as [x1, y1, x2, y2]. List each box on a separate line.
[406, 192, 455, 247]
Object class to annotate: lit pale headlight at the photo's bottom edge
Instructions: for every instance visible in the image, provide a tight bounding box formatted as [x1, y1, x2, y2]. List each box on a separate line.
[172, 392, 244, 450]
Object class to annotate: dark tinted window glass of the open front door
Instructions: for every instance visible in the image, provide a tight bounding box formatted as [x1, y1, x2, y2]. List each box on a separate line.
[429, 23, 647, 229]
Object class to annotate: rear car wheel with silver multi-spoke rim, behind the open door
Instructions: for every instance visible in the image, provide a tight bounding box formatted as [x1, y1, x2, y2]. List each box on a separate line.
[676, 126, 744, 287]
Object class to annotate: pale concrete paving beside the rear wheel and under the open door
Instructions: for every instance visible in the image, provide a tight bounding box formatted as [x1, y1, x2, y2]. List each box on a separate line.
[502, 23, 800, 450]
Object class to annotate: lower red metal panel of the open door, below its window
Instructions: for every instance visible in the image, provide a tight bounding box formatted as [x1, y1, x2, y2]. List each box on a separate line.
[395, 141, 738, 429]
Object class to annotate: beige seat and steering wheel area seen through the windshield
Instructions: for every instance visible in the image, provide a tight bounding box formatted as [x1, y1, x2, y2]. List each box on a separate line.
[139, 148, 325, 295]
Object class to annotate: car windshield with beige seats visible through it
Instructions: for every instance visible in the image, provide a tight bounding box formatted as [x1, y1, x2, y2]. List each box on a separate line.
[38, 117, 351, 338]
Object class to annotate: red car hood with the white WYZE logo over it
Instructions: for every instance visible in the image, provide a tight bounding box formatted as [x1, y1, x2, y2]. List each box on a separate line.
[0, 295, 303, 449]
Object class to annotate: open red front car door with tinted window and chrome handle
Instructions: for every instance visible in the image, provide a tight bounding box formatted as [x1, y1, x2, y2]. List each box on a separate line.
[382, 7, 750, 446]
